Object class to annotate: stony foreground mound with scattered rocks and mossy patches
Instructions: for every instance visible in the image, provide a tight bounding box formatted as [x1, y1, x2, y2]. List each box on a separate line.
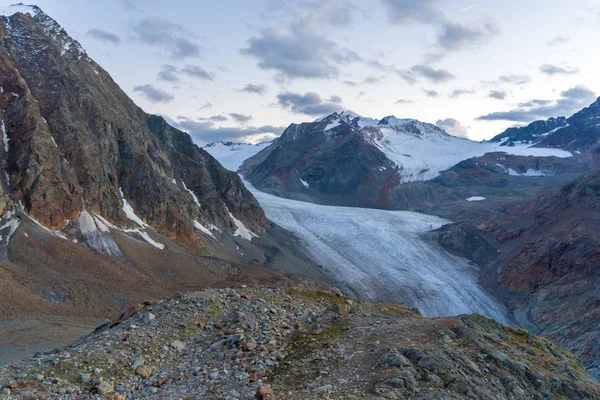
[0, 287, 600, 400]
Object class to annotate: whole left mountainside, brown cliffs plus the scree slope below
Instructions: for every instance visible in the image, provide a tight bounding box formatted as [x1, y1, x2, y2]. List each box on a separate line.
[0, 6, 328, 354]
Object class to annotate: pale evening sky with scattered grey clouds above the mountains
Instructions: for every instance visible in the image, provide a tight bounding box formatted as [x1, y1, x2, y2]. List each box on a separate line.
[0, 0, 600, 145]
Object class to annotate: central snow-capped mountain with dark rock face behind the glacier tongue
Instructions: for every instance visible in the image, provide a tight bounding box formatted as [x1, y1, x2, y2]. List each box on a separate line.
[240, 112, 577, 209]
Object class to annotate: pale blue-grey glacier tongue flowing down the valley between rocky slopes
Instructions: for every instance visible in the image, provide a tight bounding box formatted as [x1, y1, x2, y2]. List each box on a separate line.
[245, 182, 508, 323]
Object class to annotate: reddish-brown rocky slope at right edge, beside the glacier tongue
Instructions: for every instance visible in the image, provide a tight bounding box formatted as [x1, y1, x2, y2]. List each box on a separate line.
[440, 171, 600, 375]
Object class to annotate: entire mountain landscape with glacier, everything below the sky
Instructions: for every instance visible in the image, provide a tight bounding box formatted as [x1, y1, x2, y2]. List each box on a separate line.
[0, 5, 600, 398]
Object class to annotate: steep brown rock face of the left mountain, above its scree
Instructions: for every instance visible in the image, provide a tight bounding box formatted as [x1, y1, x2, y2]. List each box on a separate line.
[0, 7, 268, 250]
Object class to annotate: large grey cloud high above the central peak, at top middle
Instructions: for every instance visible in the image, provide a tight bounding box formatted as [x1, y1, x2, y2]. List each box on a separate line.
[241, 21, 361, 80]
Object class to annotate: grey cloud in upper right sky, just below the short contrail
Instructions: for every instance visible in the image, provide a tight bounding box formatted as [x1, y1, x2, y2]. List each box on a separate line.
[436, 22, 498, 52]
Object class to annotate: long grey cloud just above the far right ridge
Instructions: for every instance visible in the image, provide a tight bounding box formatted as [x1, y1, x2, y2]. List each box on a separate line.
[476, 85, 596, 122]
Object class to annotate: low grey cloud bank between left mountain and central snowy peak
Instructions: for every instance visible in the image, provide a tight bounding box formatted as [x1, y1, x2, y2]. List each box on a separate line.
[175, 118, 285, 145]
